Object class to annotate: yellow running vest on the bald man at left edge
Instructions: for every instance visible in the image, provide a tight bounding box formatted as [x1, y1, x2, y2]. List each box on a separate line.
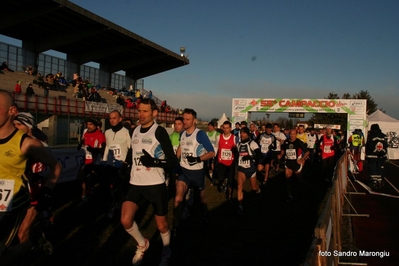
[0, 130, 29, 210]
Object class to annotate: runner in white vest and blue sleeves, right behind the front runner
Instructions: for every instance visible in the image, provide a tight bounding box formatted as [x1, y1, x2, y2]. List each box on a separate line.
[173, 108, 215, 235]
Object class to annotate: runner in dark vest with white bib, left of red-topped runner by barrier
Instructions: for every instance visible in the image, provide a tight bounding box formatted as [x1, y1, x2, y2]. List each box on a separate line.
[278, 129, 309, 202]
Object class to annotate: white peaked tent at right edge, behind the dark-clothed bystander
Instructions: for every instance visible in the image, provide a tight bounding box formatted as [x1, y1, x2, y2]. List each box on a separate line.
[368, 110, 399, 160]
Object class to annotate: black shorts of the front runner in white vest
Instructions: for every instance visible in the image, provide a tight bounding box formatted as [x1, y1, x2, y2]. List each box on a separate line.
[125, 183, 168, 216]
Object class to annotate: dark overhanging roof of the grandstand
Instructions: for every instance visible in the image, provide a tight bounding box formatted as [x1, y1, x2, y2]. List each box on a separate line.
[0, 0, 189, 79]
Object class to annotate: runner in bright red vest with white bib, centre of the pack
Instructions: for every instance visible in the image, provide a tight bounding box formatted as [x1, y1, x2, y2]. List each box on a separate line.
[216, 121, 237, 203]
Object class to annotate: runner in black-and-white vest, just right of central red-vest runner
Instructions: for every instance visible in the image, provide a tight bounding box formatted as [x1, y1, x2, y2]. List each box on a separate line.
[237, 127, 262, 214]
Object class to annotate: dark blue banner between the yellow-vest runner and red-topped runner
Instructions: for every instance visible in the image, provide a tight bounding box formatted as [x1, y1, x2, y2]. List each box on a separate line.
[52, 148, 85, 183]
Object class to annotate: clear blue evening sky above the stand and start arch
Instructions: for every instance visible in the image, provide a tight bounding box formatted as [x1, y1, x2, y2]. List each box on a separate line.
[0, 0, 399, 119]
